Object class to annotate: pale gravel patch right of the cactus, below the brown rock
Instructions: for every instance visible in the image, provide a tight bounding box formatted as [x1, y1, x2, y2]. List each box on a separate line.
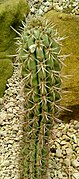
[50, 120, 79, 179]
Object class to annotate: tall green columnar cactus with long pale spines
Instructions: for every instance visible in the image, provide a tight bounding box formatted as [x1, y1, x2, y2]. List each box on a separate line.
[17, 18, 63, 179]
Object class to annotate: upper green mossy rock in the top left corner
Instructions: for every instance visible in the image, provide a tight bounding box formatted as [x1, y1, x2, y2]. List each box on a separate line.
[0, 0, 29, 58]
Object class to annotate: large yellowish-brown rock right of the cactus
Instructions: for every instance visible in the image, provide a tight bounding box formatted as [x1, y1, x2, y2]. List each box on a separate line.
[46, 10, 79, 121]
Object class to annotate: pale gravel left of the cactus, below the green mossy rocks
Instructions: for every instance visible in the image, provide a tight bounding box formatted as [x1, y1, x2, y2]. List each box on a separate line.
[0, 60, 24, 179]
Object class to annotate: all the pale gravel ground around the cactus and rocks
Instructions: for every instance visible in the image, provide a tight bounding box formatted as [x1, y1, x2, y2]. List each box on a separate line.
[0, 0, 79, 179]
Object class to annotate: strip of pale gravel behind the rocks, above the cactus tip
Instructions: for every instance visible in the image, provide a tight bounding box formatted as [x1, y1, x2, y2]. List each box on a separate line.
[28, 0, 79, 15]
